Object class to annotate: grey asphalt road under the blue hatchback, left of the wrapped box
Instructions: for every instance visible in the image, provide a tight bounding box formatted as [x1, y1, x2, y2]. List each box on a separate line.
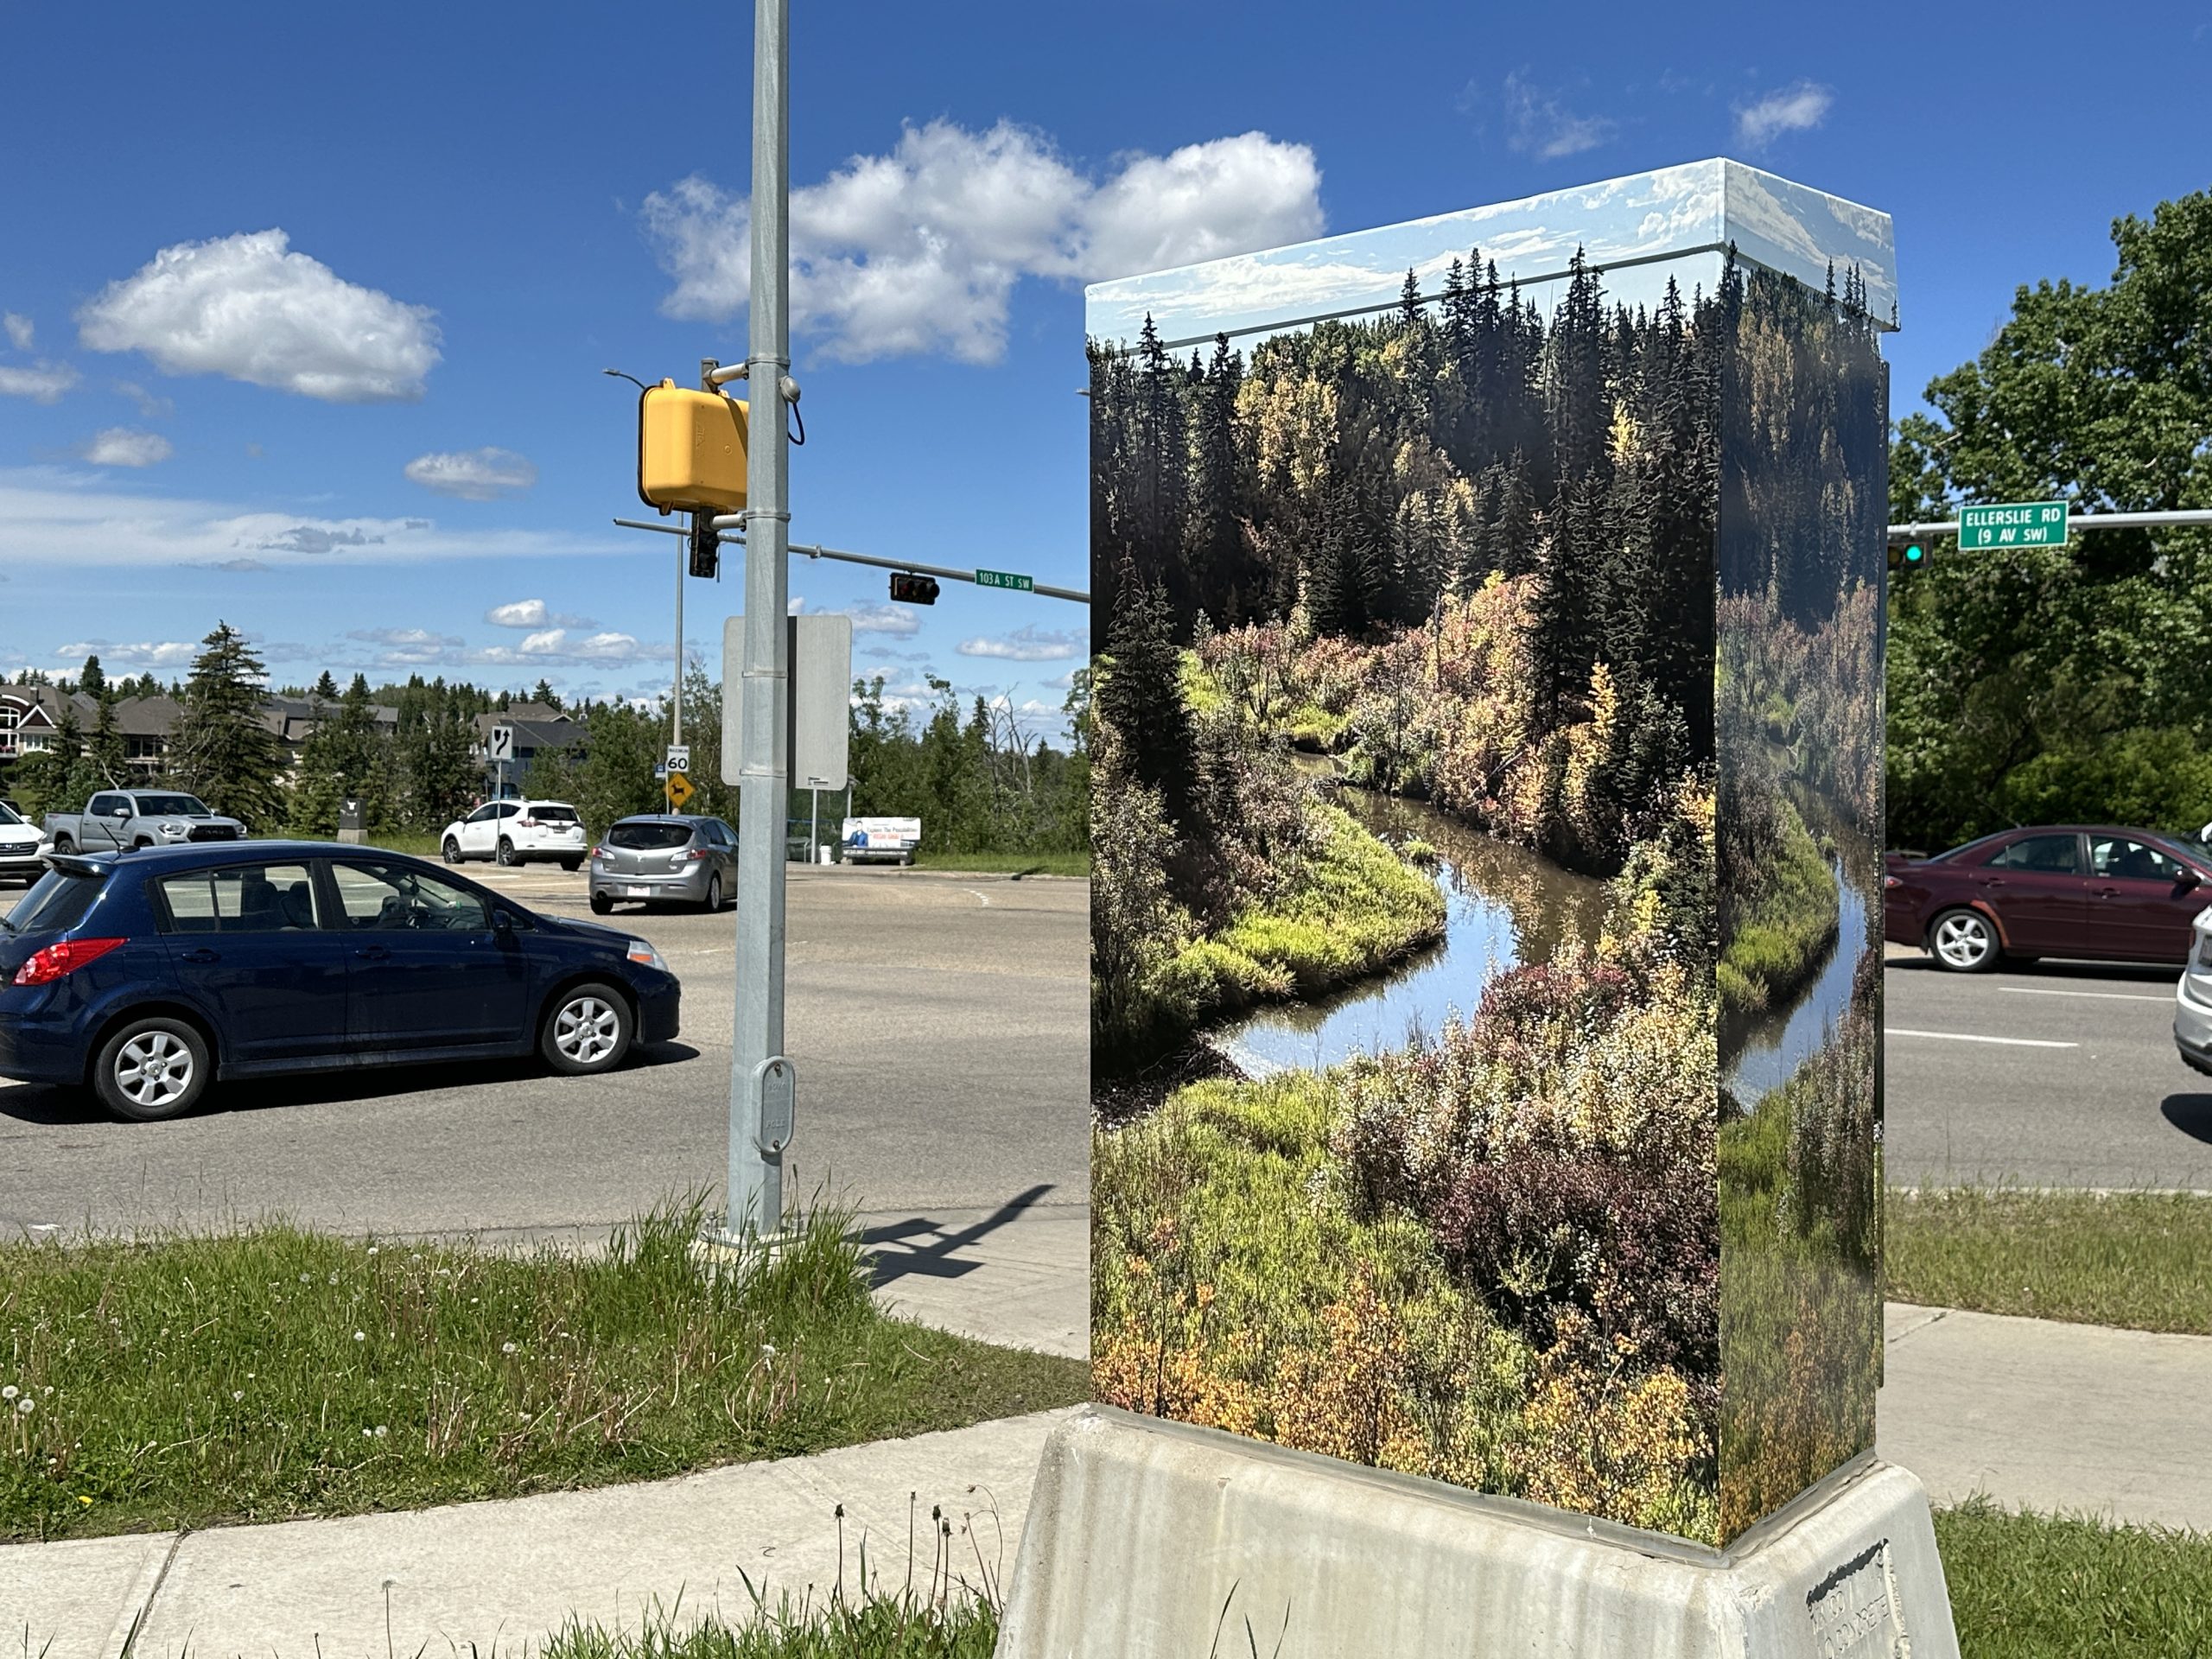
[0, 865, 1089, 1236]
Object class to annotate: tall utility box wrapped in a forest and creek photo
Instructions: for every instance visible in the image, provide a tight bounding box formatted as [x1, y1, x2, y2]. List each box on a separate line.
[1089, 162, 1896, 1544]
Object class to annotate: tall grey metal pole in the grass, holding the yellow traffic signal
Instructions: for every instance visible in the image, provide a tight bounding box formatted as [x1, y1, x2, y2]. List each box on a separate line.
[723, 0, 794, 1239]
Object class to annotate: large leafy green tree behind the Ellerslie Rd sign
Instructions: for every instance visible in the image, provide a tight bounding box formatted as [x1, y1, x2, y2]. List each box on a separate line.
[1889, 190, 2212, 847]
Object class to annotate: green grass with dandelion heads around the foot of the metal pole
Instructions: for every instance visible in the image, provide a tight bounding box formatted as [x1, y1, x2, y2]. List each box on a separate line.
[0, 1204, 1089, 1541]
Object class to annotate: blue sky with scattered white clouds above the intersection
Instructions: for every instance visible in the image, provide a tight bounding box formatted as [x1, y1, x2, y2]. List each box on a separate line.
[0, 0, 2212, 739]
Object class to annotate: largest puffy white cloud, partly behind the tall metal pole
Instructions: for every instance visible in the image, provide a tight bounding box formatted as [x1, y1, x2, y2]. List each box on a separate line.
[644, 119, 1323, 363]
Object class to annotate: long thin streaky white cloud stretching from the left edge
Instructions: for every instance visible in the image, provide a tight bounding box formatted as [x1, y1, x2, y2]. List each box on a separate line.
[0, 467, 637, 570]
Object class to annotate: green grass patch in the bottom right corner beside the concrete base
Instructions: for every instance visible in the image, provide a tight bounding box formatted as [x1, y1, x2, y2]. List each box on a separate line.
[1936, 1502, 2212, 1659]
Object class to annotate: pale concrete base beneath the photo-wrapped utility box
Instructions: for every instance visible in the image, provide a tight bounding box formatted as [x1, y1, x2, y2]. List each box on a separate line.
[998, 1407, 1958, 1659]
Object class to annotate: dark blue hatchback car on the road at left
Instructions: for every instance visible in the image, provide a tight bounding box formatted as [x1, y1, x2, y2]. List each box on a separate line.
[0, 841, 681, 1122]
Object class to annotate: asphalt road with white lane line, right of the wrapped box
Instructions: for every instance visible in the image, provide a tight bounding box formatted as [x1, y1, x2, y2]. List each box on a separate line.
[1883, 947, 2212, 1192]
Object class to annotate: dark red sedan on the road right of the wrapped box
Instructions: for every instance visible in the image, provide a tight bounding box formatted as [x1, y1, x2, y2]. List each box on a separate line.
[1883, 825, 2212, 973]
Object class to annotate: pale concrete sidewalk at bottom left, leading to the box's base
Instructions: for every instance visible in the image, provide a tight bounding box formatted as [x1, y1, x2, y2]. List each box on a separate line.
[0, 1411, 1062, 1659]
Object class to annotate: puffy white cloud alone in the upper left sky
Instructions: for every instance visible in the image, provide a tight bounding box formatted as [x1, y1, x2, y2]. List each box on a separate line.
[78, 230, 438, 403]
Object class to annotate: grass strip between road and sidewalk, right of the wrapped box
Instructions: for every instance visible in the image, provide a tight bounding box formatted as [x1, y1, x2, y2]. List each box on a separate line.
[1885, 1188, 2212, 1336]
